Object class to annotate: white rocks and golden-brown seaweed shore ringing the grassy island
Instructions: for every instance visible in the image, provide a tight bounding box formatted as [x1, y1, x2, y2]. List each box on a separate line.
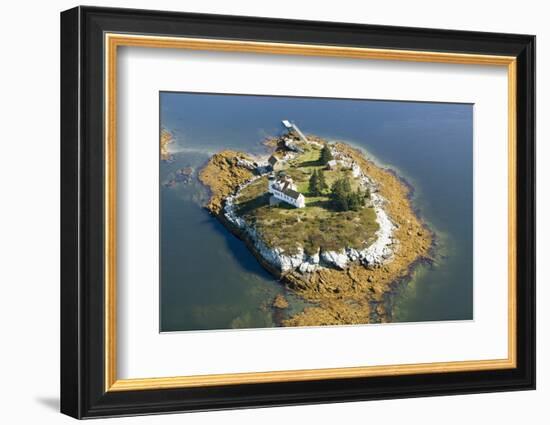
[199, 136, 434, 326]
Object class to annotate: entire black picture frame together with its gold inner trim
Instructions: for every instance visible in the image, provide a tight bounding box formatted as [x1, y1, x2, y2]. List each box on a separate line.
[61, 6, 536, 418]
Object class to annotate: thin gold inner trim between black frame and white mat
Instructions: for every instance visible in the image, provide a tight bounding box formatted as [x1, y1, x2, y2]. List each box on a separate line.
[105, 33, 516, 391]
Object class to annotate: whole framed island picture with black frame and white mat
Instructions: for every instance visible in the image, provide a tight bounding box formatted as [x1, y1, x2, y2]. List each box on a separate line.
[61, 7, 535, 418]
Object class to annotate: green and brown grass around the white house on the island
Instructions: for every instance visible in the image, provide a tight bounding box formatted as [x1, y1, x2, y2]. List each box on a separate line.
[236, 142, 378, 254]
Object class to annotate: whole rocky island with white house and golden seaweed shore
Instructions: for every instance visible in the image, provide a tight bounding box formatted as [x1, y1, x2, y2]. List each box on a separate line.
[199, 120, 434, 326]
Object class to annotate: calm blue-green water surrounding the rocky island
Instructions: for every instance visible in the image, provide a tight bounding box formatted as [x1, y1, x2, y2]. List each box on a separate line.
[160, 93, 473, 331]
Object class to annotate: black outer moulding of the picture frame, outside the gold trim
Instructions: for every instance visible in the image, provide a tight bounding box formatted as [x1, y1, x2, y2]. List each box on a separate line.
[61, 7, 535, 418]
